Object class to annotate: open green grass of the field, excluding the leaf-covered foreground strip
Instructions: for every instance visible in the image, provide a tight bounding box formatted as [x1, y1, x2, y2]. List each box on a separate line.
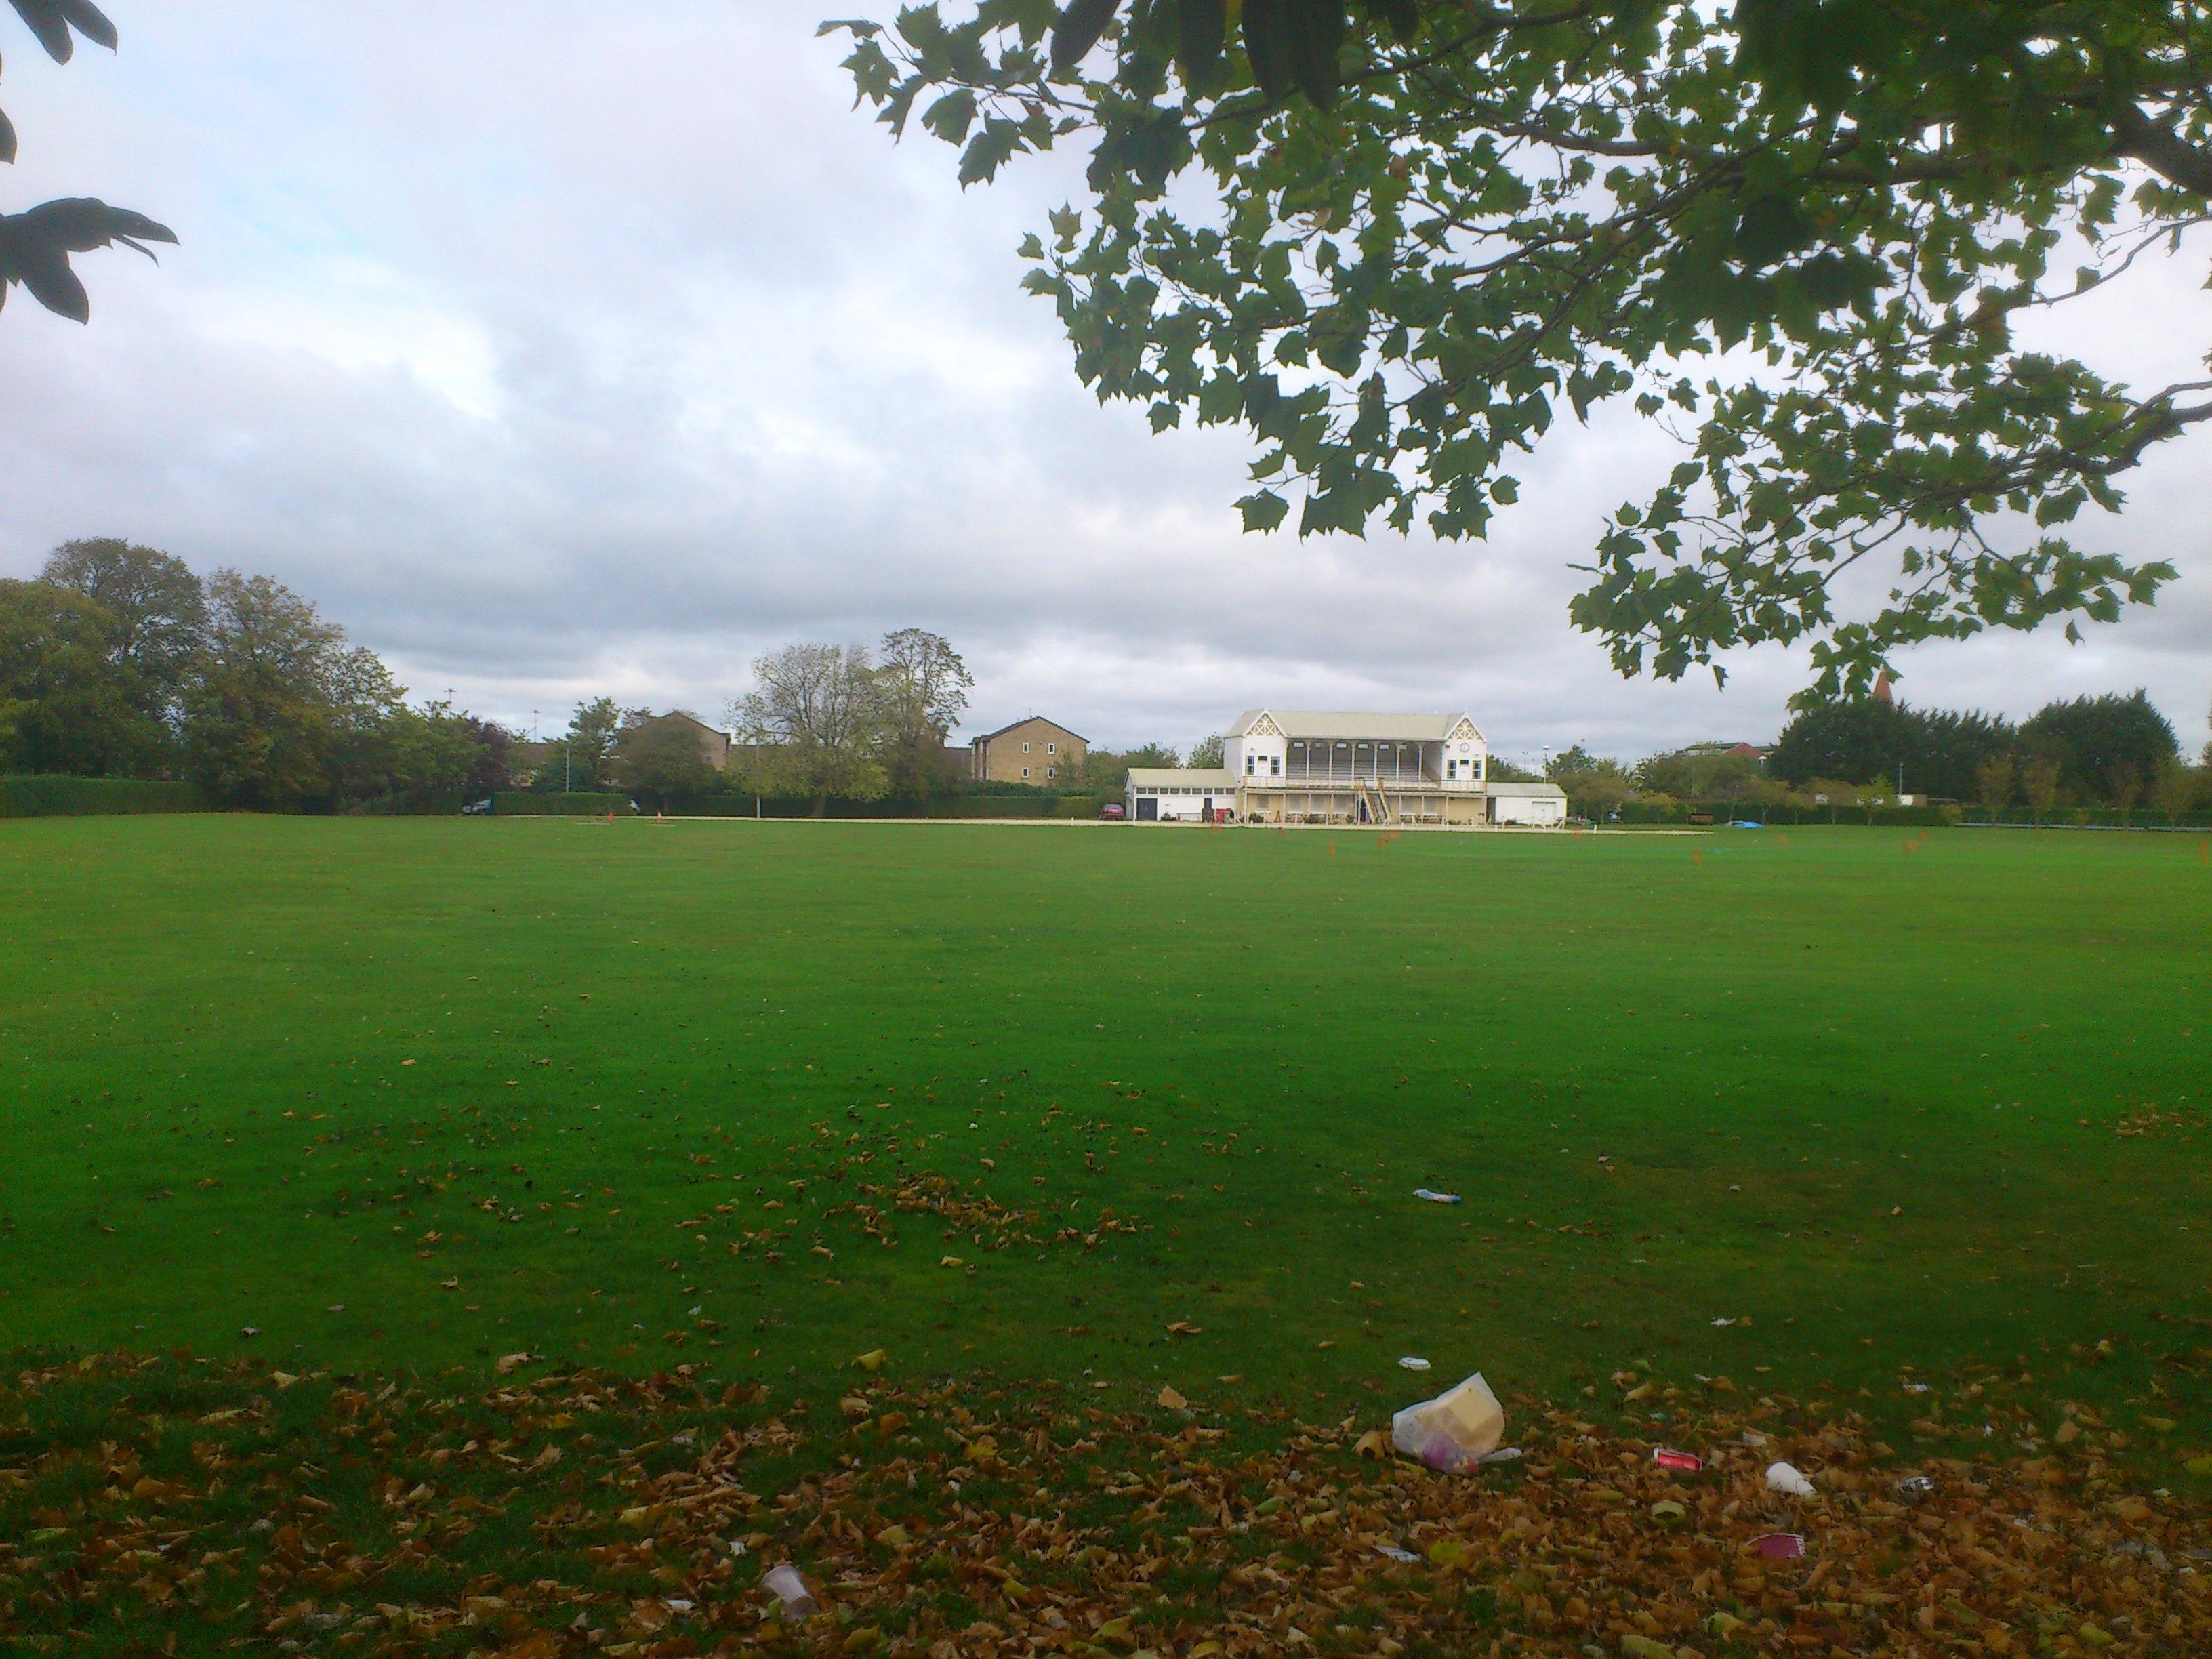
[0, 816, 2212, 1438]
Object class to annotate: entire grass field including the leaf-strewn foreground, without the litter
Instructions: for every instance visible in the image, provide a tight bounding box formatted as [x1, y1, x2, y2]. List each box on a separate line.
[0, 819, 2212, 1659]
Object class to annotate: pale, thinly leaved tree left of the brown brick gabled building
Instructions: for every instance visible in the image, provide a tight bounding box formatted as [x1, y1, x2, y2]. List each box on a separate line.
[730, 644, 891, 814]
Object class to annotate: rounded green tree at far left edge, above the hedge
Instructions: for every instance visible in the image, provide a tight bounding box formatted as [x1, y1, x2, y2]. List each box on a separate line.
[0, 579, 153, 777]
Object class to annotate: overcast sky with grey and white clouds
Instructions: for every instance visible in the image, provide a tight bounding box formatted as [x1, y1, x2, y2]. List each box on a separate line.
[0, 0, 2212, 756]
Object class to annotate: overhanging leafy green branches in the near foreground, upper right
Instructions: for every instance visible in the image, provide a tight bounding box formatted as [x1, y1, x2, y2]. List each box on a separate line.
[823, 0, 2212, 697]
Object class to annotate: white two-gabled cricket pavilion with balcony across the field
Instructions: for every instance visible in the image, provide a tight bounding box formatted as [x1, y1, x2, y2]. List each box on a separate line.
[1126, 708, 1566, 830]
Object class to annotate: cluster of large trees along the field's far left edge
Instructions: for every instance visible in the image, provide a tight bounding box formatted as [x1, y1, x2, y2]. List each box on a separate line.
[0, 537, 509, 810]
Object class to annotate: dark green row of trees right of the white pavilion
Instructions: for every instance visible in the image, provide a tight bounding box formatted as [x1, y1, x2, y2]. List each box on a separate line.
[1547, 690, 2212, 819]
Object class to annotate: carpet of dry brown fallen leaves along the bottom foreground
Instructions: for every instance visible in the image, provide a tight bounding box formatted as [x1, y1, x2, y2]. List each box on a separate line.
[0, 1354, 2212, 1659]
